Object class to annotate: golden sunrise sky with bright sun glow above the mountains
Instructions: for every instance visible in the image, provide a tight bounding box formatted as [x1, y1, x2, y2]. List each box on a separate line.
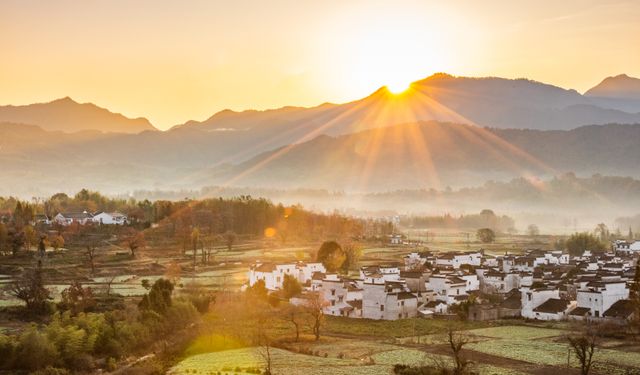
[0, 0, 640, 129]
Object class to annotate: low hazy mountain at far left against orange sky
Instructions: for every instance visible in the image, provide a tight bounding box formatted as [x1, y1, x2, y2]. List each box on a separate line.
[0, 97, 156, 133]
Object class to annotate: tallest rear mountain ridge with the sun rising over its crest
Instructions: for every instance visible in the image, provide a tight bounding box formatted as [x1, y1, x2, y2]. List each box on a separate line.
[176, 73, 640, 139]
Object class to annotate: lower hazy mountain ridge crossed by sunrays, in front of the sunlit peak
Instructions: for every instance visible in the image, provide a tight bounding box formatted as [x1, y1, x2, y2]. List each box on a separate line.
[192, 122, 640, 191]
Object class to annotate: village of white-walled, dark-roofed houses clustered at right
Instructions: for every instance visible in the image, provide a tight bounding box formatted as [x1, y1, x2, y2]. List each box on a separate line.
[249, 246, 640, 321]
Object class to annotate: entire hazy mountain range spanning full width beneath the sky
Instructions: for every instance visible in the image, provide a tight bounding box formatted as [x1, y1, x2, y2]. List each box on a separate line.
[0, 74, 640, 201]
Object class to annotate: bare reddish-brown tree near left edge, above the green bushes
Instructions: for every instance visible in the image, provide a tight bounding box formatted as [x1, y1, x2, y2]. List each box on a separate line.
[9, 261, 51, 313]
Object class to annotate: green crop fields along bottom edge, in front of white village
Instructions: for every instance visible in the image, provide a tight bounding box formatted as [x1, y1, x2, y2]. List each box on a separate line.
[171, 324, 640, 375]
